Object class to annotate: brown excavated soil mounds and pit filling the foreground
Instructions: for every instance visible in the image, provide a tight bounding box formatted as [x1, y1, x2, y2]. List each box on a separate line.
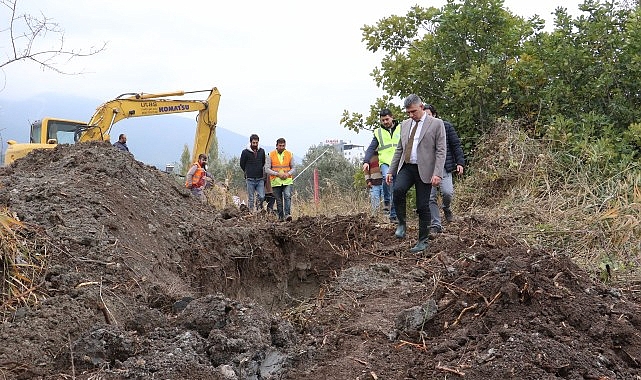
[0, 143, 641, 380]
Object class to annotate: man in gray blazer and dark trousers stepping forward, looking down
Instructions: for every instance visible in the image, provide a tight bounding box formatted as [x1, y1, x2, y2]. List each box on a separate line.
[385, 94, 446, 253]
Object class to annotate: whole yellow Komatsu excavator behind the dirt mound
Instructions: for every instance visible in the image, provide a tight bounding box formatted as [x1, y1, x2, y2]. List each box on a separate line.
[4, 87, 220, 165]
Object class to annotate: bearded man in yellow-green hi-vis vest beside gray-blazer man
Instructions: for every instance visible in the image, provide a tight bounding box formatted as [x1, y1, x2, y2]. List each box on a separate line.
[363, 108, 401, 222]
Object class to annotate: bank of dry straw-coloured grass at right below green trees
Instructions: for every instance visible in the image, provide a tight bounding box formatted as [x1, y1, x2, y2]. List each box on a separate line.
[455, 124, 641, 281]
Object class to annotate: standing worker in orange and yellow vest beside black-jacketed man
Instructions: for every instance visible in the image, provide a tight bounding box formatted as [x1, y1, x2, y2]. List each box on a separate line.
[265, 137, 294, 222]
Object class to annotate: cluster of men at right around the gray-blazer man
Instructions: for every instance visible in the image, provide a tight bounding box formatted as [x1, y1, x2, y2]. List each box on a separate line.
[363, 94, 465, 253]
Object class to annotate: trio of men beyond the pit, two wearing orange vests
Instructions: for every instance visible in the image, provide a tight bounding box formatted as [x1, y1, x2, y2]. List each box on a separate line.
[185, 134, 295, 221]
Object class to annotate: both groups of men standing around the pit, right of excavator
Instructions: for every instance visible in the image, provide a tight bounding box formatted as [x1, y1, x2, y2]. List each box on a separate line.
[181, 94, 465, 253]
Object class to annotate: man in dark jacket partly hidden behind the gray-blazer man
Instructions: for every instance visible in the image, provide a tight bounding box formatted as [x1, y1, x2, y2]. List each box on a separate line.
[425, 104, 465, 233]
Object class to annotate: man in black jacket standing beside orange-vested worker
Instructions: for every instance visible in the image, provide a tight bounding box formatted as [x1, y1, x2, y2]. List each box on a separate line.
[240, 134, 265, 210]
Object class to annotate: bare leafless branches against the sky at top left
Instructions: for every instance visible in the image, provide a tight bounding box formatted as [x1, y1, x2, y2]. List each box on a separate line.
[0, 0, 107, 75]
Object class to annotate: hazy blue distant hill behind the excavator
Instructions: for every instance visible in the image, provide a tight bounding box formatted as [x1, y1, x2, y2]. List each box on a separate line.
[0, 93, 264, 169]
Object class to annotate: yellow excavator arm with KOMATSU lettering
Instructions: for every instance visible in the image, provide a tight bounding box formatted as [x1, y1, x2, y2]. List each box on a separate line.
[77, 87, 220, 162]
